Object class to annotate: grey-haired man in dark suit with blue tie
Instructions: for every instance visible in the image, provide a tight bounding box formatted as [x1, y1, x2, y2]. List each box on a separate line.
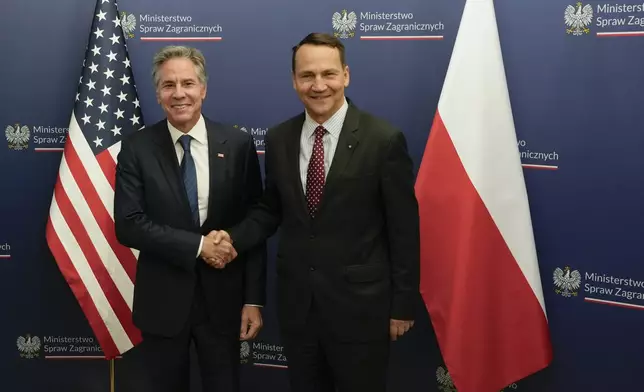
[114, 47, 266, 392]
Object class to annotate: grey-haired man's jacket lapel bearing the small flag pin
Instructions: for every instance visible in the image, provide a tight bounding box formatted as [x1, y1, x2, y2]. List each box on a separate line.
[203, 119, 229, 226]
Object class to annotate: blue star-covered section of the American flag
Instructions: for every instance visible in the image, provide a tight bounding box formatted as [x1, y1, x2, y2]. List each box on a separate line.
[74, 0, 143, 154]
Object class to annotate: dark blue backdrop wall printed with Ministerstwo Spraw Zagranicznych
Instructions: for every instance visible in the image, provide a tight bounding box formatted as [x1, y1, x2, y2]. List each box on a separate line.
[0, 0, 644, 392]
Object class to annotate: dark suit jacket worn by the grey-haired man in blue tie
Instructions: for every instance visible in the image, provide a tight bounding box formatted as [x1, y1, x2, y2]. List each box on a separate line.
[114, 118, 266, 336]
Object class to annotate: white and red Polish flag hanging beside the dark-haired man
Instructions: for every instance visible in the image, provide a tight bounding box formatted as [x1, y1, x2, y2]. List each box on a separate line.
[416, 0, 552, 392]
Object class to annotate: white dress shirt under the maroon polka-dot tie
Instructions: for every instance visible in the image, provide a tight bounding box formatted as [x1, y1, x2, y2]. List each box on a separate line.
[300, 98, 349, 194]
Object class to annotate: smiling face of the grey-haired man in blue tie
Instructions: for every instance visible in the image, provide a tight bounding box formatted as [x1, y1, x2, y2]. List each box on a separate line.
[156, 58, 206, 132]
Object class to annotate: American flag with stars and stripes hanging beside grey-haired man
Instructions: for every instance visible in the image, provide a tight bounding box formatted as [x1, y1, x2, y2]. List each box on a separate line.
[46, 0, 143, 359]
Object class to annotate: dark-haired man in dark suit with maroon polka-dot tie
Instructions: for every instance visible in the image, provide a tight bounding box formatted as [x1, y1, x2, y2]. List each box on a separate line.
[215, 34, 420, 392]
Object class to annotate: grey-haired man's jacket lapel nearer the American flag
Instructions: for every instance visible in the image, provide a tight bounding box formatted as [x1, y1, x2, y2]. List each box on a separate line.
[155, 122, 191, 218]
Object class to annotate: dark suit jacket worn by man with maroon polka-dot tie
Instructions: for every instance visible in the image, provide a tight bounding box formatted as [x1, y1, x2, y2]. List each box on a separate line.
[229, 103, 420, 340]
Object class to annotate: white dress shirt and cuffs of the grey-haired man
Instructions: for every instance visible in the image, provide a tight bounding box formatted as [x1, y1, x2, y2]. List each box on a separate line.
[168, 115, 261, 307]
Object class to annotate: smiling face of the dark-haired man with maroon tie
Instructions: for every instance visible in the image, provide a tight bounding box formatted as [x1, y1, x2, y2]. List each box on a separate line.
[293, 44, 349, 124]
